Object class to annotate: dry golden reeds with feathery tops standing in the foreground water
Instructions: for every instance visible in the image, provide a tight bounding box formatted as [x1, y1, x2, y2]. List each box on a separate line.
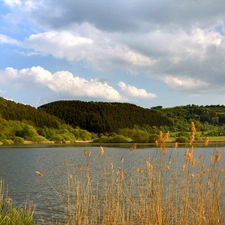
[37, 123, 225, 225]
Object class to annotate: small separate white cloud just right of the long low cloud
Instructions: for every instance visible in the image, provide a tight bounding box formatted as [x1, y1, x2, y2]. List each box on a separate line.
[118, 81, 157, 98]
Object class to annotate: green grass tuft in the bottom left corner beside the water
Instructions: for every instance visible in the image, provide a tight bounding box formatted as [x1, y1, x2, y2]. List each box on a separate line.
[0, 179, 36, 225]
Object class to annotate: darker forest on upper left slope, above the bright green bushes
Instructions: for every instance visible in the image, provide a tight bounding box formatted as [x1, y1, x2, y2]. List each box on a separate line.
[0, 97, 62, 128]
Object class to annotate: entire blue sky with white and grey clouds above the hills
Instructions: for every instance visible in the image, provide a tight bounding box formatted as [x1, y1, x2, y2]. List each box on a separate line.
[0, 0, 225, 108]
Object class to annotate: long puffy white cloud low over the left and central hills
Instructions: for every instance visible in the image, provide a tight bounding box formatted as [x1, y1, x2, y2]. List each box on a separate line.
[0, 67, 125, 101]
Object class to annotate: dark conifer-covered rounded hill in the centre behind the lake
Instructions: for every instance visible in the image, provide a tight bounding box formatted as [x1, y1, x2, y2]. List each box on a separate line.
[38, 101, 173, 133]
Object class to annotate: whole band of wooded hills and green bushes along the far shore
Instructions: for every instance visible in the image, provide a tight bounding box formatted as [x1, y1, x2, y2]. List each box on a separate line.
[0, 97, 225, 144]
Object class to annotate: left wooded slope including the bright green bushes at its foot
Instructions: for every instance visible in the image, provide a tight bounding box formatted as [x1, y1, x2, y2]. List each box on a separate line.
[0, 97, 92, 144]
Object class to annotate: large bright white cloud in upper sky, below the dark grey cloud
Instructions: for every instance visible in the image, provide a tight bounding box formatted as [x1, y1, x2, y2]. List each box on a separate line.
[21, 23, 156, 72]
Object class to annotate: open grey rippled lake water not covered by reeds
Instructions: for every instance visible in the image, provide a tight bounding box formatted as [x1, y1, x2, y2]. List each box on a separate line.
[0, 145, 225, 224]
